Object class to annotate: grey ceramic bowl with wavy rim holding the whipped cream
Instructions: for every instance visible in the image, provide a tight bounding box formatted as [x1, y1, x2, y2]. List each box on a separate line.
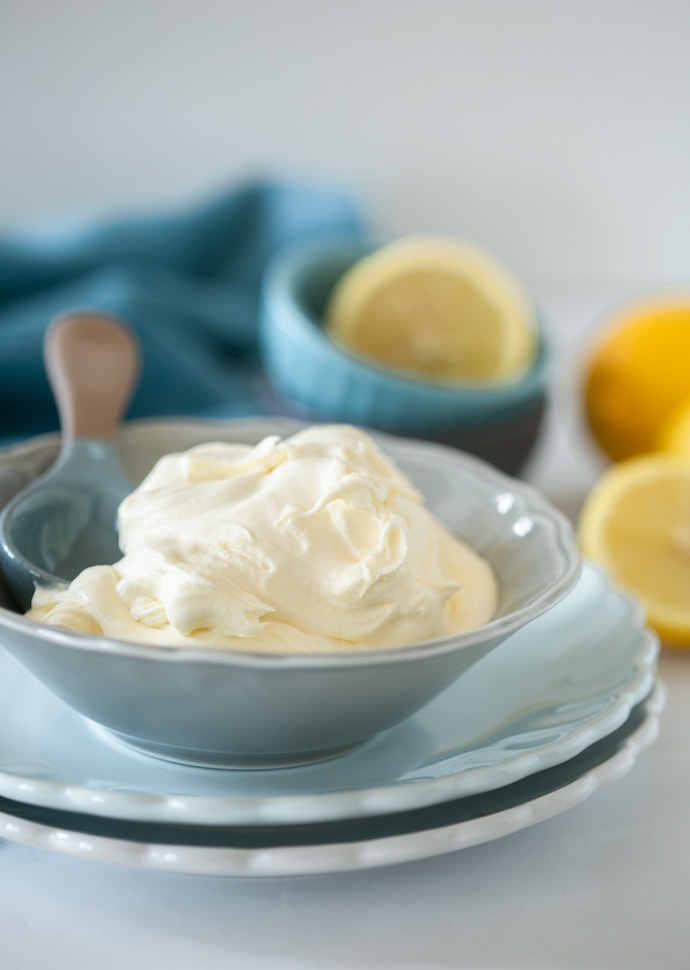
[0, 419, 580, 767]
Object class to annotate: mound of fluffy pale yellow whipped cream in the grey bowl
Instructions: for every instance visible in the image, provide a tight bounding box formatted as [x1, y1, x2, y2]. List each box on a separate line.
[29, 425, 496, 652]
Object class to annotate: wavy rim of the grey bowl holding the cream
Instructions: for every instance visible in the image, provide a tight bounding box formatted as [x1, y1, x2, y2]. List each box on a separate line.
[0, 415, 582, 670]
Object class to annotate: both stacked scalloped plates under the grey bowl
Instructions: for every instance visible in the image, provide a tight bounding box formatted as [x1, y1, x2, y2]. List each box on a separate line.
[0, 565, 664, 876]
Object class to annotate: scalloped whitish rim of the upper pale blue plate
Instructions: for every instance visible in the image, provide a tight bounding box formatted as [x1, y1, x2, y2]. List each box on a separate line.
[0, 564, 659, 825]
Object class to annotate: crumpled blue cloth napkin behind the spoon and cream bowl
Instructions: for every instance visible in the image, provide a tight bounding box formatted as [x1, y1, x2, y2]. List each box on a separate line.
[0, 181, 363, 442]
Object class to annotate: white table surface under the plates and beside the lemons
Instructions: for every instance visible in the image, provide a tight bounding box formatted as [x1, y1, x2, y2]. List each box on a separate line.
[0, 278, 690, 970]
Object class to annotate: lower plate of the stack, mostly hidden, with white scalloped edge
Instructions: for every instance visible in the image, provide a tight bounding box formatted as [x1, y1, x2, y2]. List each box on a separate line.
[0, 685, 665, 877]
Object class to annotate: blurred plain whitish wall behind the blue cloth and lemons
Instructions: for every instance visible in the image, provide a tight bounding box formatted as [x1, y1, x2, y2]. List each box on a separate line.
[0, 0, 690, 286]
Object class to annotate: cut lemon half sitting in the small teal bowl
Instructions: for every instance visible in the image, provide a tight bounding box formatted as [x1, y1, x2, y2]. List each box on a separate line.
[325, 236, 537, 381]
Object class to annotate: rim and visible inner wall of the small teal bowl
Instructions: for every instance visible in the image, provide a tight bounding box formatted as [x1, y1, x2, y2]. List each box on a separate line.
[260, 236, 550, 406]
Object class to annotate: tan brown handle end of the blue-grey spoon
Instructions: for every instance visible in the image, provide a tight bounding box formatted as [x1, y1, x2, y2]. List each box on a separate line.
[44, 311, 139, 441]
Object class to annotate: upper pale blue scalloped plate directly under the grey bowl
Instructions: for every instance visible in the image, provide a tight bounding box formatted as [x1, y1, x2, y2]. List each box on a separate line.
[0, 566, 658, 825]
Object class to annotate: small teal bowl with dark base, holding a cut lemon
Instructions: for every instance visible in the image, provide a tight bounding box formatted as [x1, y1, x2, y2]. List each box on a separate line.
[260, 239, 548, 474]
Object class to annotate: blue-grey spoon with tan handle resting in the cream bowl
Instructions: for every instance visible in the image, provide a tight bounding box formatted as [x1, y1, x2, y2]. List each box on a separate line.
[0, 312, 139, 610]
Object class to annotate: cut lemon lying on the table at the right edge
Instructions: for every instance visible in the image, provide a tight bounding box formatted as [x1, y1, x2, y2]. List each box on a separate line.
[578, 454, 690, 648]
